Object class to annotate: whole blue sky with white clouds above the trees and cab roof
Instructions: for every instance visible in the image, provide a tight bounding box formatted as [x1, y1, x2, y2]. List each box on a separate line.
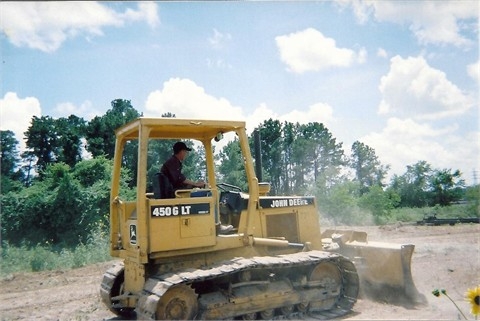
[0, 0, 480, 185]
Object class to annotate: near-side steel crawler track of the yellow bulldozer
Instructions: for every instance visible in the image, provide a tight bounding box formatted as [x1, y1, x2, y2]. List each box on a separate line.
[125, 251, 359, 320]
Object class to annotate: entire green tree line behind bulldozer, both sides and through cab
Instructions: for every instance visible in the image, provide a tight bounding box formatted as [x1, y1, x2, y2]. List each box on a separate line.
[0, 99, 476, 246]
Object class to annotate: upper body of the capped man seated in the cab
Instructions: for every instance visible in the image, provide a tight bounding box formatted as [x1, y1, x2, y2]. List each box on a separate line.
[160, 142, 206, 190]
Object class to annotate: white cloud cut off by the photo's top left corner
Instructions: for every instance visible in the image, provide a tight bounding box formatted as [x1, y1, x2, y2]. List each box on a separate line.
[0, 1, 159, 52]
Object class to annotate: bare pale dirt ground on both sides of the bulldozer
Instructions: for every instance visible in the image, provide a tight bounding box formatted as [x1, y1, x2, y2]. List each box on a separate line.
[0, 224, 480, 320]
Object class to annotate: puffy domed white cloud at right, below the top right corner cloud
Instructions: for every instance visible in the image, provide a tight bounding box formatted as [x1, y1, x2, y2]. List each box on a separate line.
[379, 56, 474, 119]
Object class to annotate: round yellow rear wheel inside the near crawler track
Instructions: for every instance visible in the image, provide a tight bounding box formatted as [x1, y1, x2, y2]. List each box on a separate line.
[156, 284, 198, 320]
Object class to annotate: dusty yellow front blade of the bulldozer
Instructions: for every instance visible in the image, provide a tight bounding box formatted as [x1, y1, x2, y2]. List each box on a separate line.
[322, 230, 426, 305]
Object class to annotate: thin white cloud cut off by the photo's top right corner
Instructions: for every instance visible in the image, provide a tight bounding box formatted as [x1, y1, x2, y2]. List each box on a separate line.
[337, 0, 479, 46]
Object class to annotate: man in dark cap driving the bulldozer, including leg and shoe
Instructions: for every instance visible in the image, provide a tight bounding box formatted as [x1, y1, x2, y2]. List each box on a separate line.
[160, 142, 233, 234]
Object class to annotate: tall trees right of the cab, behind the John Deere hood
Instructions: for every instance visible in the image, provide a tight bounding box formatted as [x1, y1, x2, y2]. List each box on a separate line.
[251, 119, 466, 207]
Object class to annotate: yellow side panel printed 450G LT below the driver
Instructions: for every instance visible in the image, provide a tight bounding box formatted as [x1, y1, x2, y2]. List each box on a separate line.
[147, 197, 216, 253]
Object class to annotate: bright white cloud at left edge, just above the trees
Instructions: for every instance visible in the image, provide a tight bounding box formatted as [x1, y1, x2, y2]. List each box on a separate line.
[0, 92, 42, 150]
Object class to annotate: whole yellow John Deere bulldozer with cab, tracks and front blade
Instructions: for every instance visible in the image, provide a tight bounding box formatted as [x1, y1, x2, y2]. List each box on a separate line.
[100, 117, 419, 320]
